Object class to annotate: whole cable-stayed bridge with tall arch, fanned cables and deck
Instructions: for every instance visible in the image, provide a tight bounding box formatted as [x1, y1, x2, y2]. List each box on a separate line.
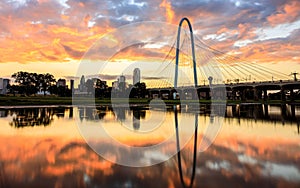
[142, 18, 300, 101]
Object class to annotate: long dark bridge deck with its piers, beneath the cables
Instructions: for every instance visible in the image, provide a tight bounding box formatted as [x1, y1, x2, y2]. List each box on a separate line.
[149, 80, 300, 101]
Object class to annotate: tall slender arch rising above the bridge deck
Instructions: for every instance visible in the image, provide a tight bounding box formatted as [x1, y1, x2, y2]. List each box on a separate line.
[174, 18, 198, 88]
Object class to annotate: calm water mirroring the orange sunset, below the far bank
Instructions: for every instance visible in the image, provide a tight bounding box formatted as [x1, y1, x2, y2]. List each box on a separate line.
[0, 105, 300, 187]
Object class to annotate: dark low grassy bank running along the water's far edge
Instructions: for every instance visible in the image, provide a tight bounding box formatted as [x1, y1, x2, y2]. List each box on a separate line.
[0, 96, 300, 106]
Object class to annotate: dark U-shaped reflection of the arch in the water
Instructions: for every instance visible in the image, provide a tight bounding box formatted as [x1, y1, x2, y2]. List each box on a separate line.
[174, 109, 198, 187]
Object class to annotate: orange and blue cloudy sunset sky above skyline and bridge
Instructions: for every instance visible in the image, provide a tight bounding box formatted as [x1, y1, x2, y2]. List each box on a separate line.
[0, 0, 300, 84]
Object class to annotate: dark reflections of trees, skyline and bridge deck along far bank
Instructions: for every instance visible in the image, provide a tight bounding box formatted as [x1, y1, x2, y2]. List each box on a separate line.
[0, 104, 300, 134]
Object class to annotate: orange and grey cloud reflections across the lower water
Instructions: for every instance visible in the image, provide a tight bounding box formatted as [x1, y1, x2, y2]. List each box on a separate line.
[0, 118, 300, 188]
